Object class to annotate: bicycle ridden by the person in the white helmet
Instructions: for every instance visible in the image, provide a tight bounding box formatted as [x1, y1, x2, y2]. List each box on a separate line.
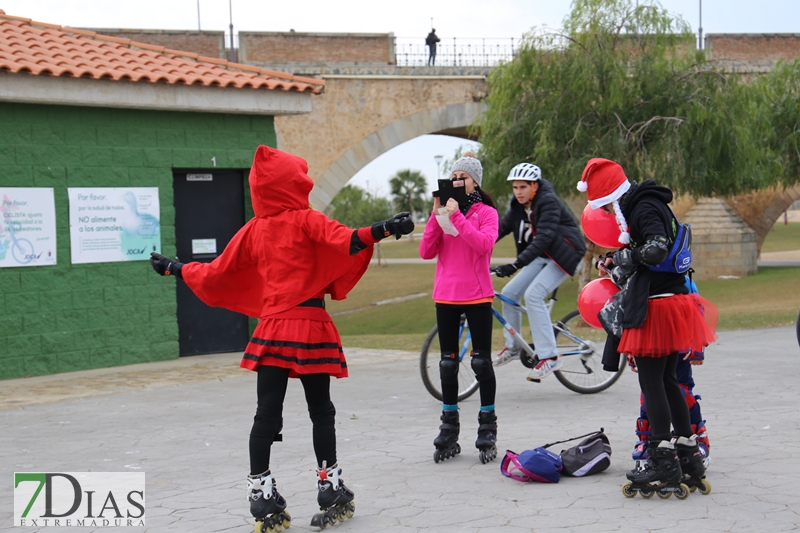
[419, 289, 627, 401]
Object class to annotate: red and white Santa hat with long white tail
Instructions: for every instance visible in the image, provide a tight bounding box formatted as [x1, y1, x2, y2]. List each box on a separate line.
[578, 157, 631, 244]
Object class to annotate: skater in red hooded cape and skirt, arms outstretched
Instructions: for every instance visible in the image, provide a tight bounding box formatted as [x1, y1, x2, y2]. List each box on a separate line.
[150, 146, 414, 530]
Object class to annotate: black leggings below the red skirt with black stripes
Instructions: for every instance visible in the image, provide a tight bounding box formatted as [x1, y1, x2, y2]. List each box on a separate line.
[250, 366, 336, 475]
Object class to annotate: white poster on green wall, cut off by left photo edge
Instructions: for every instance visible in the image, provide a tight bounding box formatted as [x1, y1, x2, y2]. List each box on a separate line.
[0, 187, 56, 267]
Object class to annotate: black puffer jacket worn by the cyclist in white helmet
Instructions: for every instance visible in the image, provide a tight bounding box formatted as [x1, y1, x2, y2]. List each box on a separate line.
[498, 180, 586, 276]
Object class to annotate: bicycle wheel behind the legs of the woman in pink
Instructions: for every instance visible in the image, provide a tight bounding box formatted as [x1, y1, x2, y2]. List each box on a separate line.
[419, 318, 478, 402]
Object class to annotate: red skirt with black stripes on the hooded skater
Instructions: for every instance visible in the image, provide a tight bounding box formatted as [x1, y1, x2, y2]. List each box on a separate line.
[239, 307, 347, 378]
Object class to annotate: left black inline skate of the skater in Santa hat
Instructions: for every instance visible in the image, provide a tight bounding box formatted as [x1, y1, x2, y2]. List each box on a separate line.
[622, 440, 689, 500]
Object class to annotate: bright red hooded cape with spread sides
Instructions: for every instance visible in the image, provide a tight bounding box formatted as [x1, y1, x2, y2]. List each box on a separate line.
[182, 146, 373, 317]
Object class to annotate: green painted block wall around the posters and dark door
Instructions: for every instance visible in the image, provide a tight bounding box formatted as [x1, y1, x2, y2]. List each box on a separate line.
[0, 102, 275, 379]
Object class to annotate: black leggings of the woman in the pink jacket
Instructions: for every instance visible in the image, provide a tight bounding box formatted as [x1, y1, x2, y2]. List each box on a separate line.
[436, 303, 497, 406]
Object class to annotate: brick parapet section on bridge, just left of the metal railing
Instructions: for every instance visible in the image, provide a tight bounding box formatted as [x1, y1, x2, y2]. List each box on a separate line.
[239, 31, 395, 65]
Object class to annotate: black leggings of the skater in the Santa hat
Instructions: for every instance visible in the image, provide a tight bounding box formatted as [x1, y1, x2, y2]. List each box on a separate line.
[636, 353, 692, 442]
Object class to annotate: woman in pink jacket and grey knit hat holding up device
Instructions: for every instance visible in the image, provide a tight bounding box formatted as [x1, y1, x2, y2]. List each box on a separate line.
[419, 152, 499, 463]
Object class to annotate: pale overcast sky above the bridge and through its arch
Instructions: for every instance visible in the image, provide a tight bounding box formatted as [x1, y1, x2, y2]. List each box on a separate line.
[7, 0, 800, 195]
